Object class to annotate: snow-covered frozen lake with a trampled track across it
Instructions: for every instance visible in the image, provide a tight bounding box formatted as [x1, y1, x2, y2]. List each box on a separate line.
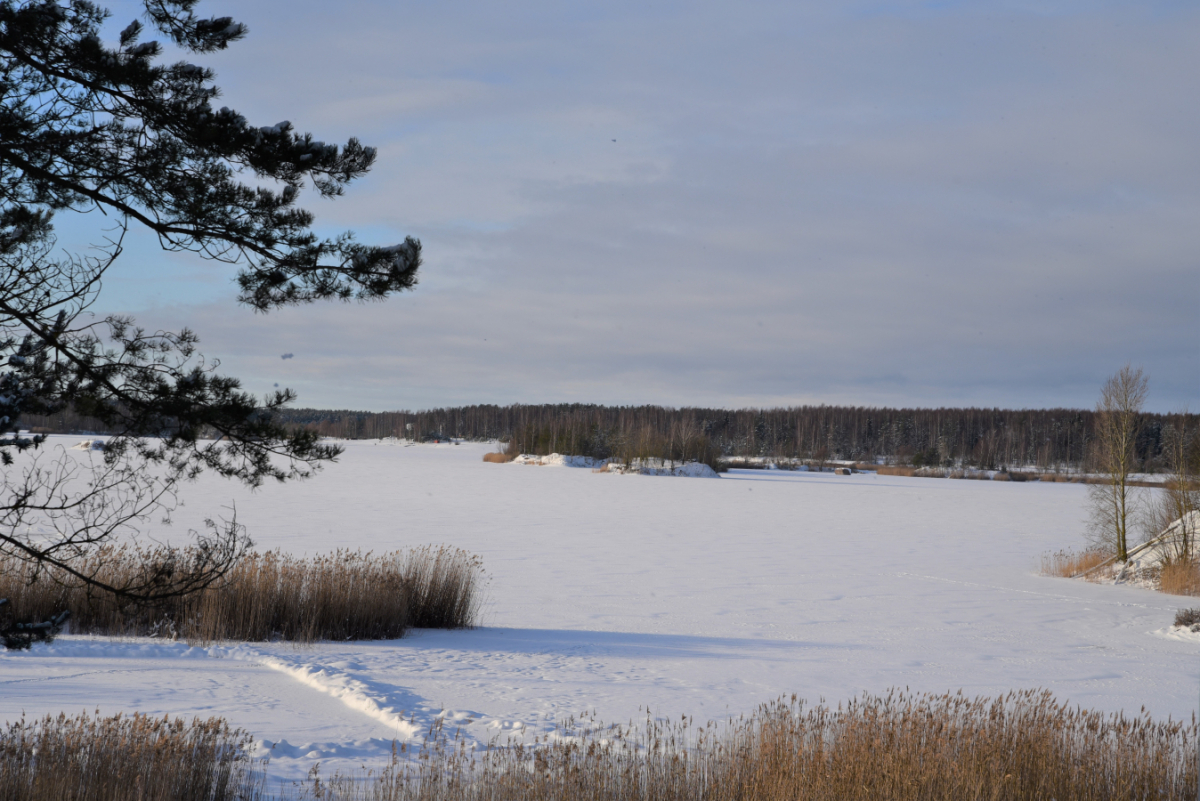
[0, 439, 1200, 777]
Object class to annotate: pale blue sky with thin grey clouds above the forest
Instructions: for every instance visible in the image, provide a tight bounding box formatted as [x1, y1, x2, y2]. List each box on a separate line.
[68, 0, 1200, 411]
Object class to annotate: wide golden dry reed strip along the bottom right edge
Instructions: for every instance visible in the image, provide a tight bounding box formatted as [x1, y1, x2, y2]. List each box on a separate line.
[305, 691, 1196, 801]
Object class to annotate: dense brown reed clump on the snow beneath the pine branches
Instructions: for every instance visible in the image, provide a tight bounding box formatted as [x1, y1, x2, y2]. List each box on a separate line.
[0, 547, 482, 643]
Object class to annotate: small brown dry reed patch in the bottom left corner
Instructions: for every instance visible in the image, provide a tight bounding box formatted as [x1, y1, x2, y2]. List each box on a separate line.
[0, 713, 263, 801]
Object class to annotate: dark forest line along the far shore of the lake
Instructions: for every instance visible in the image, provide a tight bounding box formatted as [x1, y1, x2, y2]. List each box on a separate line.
[23, 404, 1200, 470]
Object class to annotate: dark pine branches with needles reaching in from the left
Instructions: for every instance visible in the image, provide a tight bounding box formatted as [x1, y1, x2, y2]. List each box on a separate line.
[0, 0, 421, 600]
